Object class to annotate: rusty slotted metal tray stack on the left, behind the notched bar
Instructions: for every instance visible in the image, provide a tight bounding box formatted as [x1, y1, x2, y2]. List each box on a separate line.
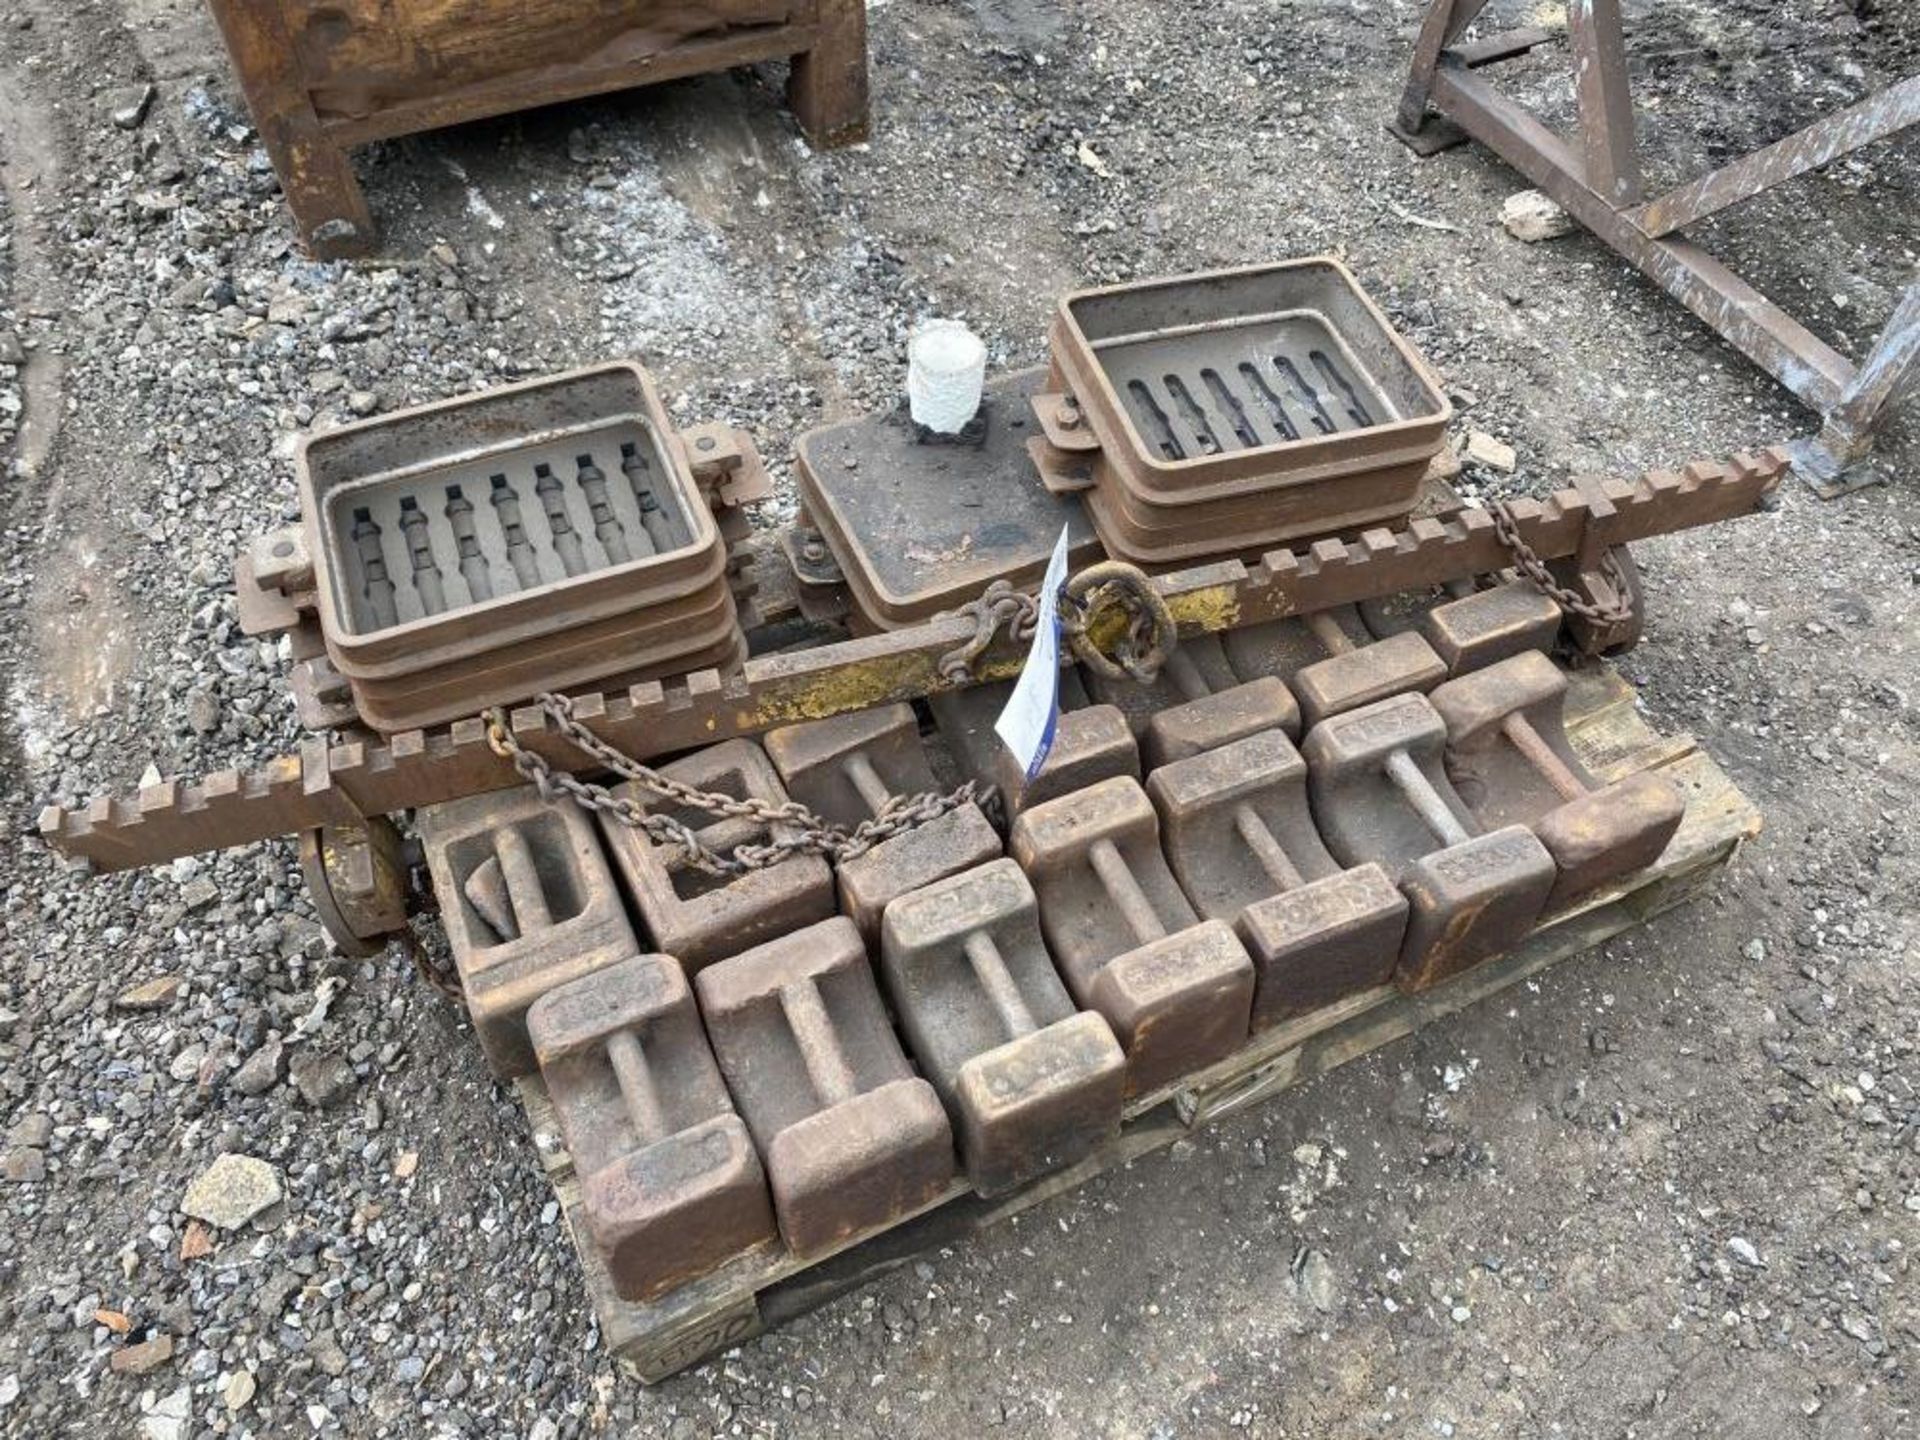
[251, 363, 764, 732]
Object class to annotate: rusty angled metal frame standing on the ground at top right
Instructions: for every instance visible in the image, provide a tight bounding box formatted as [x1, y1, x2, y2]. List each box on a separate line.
[1388, 0, 1920, 497]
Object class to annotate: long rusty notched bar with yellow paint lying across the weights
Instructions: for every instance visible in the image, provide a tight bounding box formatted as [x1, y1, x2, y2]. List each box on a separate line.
[40, 451, 1788, 872]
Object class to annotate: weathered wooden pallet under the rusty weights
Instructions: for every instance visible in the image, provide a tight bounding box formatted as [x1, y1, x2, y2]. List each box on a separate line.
[518, 666, 1761, 1380]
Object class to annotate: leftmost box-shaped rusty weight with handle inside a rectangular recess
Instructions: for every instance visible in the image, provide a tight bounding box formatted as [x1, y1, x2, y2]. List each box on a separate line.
[415, 785, 639, 1079]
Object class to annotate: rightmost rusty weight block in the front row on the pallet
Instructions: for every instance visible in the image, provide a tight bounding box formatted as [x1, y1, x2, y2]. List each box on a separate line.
[1432, 651, 1686, 910]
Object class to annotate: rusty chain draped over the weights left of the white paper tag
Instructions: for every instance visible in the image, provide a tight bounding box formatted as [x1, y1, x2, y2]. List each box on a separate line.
[486, 695, 998, 876]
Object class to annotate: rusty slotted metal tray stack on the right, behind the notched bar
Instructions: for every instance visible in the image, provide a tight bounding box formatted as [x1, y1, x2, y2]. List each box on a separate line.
[1033, 257, 1452, 564]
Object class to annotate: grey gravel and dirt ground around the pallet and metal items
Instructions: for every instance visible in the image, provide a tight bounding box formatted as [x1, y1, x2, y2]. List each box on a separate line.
[0, 0, 1920, 1440]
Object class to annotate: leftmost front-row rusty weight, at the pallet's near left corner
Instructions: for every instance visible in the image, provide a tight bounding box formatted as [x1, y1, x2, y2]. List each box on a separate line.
[526, 954, 776, 1300]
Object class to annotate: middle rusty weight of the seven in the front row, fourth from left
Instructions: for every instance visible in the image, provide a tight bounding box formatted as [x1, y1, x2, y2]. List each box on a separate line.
[1012, 780, 1254, 1094]
